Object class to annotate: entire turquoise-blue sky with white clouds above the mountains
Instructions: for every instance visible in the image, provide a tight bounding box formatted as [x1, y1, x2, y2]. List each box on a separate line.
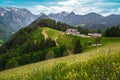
[0, 0, 120, 16]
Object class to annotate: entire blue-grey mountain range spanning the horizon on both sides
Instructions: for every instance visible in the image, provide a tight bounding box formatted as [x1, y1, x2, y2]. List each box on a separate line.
[0, 7, 120, 37]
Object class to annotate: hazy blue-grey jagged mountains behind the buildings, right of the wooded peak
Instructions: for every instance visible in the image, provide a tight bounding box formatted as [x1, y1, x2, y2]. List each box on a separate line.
[48, 12, 120, 30]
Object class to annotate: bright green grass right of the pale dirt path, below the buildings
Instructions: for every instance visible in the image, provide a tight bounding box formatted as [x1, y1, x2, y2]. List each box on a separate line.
[42, 28, 78, 47]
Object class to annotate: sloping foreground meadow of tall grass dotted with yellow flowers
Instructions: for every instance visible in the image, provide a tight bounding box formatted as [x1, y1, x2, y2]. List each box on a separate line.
[0, 42, 120, 80]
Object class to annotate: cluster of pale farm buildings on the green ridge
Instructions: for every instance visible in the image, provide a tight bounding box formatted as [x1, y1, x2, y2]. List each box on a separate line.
[66, 29, 102, 38]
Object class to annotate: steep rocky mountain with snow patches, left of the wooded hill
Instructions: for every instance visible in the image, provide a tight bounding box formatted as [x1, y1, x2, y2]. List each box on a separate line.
[0, 7, 38, 38]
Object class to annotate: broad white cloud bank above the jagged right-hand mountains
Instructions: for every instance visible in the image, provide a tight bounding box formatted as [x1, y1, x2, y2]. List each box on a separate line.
[26, 0, 120, 16]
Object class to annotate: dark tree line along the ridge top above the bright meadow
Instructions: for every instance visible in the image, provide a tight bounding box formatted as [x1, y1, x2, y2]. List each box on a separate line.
[29, 19, 74, 31]
